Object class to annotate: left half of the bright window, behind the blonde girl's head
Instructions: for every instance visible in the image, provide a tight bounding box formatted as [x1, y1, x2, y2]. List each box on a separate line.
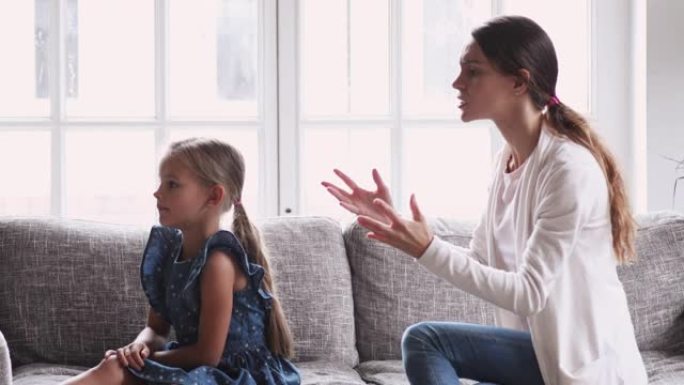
[0, 0, 275, 224]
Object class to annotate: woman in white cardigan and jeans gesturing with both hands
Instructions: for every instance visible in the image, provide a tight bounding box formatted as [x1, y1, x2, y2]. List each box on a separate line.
[323, 17, 648, 385]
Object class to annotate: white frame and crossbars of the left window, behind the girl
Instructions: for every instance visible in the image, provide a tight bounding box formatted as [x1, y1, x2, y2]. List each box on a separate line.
[0, 0, 278, 217]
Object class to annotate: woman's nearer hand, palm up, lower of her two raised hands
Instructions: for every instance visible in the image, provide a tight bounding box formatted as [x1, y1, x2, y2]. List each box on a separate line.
[358, 194, 433, 258]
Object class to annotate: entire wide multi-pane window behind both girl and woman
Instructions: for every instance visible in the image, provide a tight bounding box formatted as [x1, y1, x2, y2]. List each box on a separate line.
[0, 0, 592, 225]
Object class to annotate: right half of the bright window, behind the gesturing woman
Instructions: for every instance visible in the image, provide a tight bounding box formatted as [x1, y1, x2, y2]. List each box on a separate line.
[292, 0, 591, 219]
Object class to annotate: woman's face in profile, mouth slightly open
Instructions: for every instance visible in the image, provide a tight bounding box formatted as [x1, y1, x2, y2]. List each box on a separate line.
[451, 41, 516, 122]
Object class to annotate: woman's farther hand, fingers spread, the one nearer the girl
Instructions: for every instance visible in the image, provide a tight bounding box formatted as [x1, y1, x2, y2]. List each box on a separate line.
[321, 169, 392, 224]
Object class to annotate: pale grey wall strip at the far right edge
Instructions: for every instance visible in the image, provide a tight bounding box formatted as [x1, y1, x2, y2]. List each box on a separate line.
[647, 0, 684, 211]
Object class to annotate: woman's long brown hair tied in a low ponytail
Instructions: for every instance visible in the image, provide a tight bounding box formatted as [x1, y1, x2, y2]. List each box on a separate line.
[472, 16, 636, 263]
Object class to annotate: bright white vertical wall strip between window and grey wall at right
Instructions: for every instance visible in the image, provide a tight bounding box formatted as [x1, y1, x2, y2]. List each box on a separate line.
[591, 0, 647, 212]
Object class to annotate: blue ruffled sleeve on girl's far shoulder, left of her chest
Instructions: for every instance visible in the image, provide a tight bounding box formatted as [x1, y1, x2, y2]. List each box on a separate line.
[140, 226, 183, 323]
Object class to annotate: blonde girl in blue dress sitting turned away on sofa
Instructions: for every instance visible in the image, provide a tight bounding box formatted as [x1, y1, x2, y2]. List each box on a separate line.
[65, 139, 300, 385]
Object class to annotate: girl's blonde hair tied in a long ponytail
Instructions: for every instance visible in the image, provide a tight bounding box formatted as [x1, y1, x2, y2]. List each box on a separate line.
[162, 138, 294, 358]
